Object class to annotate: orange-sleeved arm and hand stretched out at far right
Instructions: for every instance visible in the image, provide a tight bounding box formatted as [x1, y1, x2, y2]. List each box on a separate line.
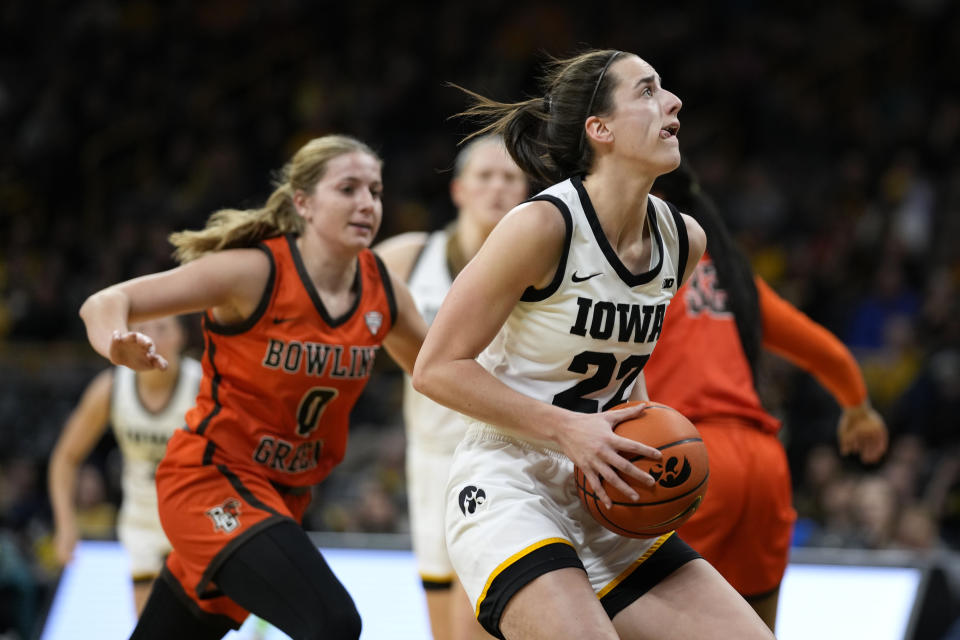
[756, 277, 888, 463]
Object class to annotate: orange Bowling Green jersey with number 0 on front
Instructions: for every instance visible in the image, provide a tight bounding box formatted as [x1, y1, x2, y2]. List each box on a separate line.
[186, 235, 397, 486]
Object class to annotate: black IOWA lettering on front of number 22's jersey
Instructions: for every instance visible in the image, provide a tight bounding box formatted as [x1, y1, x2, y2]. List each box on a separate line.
[570, 297, 667, 342]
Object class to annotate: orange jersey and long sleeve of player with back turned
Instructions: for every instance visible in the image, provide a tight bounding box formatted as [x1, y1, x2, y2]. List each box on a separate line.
[643, 253, 866, 433]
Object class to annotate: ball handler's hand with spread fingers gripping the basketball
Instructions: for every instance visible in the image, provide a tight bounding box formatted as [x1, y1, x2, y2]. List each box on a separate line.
[559, 404, 662, 508]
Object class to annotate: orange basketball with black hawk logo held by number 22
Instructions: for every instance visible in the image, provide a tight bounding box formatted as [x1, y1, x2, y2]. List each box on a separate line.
[574, 402, 710, 538]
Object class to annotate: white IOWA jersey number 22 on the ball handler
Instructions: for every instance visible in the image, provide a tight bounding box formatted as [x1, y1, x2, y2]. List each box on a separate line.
[478, 172, 689, 446]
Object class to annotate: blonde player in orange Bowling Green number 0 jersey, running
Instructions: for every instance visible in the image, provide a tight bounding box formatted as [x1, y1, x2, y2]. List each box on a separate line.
[80, 135, 426, 640]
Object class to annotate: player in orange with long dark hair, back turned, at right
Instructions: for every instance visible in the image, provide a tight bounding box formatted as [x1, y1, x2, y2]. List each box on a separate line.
[645, 164, 887, 629]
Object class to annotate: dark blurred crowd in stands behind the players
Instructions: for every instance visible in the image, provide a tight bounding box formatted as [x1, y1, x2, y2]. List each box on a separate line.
[0, 0, 960, 639]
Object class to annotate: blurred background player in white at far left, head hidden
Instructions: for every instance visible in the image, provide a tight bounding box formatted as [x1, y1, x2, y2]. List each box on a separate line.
[48, 316, 202, 614]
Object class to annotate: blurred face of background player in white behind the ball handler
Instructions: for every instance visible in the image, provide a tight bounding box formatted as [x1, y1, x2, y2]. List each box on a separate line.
[450, 142, 527, 233]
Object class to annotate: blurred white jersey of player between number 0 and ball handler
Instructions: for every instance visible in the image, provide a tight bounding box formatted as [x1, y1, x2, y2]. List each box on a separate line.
[403, 230, 467, 453]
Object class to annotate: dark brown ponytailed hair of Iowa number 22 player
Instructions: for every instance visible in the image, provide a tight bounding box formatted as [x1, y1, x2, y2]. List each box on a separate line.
[452, 49, 625, 184]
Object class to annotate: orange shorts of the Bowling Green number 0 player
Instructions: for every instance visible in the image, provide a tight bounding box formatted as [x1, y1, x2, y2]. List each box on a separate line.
[157, 430, 310, 626]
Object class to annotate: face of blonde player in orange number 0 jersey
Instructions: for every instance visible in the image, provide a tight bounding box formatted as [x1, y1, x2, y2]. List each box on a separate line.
[294, 151, 383, 251]
